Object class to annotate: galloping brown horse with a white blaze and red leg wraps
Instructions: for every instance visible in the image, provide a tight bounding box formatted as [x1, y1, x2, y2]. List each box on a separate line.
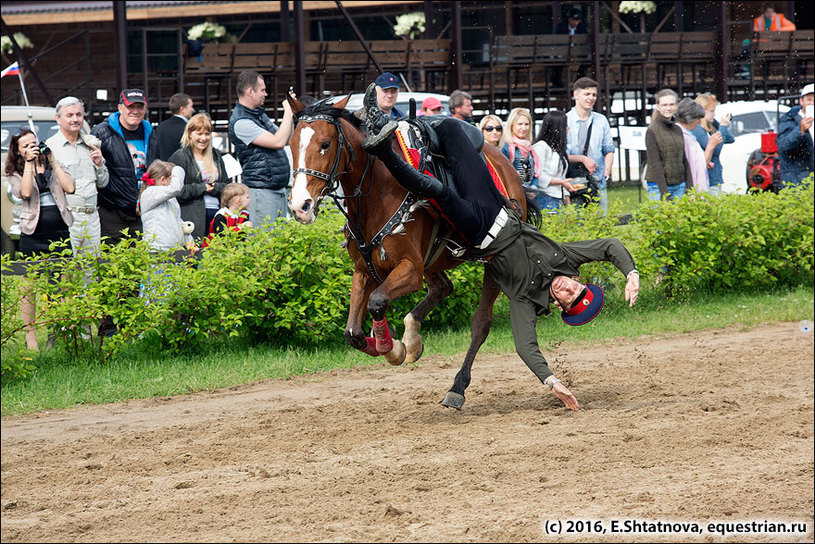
[288, 96, 527, 409]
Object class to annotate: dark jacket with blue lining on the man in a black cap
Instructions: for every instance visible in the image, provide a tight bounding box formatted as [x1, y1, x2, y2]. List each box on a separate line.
[91, 112, 158, 218]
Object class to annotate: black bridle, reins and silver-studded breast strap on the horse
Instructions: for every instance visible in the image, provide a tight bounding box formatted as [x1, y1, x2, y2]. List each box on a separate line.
[294, 114, 418, 283]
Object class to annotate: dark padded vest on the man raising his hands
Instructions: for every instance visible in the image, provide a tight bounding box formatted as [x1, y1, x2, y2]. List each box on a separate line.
[229, 102, 291, 190]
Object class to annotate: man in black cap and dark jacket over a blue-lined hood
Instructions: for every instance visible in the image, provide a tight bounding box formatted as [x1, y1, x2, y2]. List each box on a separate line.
[91, 89, 158, 242]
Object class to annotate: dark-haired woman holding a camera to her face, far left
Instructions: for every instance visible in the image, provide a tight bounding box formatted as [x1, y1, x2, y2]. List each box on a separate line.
[5, 129, 74, 350]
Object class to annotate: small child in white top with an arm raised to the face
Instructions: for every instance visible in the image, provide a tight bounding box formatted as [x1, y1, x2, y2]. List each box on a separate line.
[136, 160, 188, 250]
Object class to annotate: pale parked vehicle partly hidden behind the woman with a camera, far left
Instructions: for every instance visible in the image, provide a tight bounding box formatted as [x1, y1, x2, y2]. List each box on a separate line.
[0, 106, 90, 255]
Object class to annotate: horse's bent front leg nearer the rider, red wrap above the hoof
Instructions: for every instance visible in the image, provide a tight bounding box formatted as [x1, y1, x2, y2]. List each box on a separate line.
[368, 260, 422, 365]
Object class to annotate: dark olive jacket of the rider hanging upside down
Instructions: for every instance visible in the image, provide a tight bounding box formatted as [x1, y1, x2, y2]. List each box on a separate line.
[472, 212, 636, 382]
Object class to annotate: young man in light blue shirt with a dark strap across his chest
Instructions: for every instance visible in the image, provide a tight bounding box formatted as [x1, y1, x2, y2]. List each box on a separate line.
[566, 77, 614, 211]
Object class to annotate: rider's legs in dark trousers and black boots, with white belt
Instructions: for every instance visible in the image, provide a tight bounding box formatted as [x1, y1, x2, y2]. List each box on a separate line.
[362, 83, 507, 249]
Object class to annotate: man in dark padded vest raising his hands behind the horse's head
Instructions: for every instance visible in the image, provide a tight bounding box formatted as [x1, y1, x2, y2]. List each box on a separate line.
[229, 71, 294, 226]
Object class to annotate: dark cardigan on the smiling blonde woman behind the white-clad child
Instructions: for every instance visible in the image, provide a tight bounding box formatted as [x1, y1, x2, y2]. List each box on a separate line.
[169, 147, 229, 238]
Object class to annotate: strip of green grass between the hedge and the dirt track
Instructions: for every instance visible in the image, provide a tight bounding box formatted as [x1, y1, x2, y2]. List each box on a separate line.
[2, 286, 815, 416]
